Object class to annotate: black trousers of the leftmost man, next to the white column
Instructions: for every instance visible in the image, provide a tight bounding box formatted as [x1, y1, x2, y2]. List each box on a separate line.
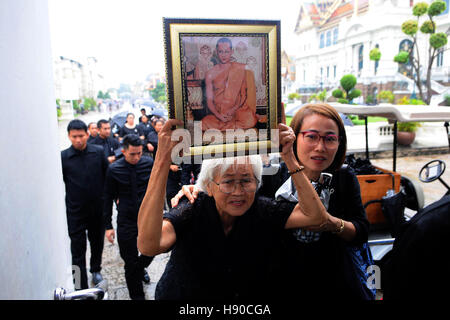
[67, 203, 105, 290]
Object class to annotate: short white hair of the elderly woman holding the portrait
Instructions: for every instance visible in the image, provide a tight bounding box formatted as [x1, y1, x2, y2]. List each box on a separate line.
[195, 154, 262, 192]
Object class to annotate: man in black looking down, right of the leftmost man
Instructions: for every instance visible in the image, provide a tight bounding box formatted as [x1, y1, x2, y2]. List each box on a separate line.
[104, 134, 153, 300]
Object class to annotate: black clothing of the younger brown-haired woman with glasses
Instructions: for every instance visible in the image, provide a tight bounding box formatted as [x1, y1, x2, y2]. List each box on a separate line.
[261, 163, 369, 300]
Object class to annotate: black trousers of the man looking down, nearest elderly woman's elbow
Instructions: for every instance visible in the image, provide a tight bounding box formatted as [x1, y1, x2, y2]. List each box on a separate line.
[117, 218, 153, 300]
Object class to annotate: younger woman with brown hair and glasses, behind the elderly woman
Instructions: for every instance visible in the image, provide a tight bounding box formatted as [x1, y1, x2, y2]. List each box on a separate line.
[172, 104, 373, 300]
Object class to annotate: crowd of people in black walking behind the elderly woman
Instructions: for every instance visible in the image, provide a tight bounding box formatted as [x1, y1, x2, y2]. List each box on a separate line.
[61, 109, 198, 300]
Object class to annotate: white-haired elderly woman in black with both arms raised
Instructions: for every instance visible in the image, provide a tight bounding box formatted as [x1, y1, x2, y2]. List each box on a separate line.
[138, 119, 326, 301]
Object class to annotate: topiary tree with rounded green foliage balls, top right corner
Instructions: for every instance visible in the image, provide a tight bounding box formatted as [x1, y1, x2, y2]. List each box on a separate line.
[394, 0, 450, 104]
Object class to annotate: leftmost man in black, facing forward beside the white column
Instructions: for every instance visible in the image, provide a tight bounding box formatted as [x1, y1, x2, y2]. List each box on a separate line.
[61, 119, 108, 289]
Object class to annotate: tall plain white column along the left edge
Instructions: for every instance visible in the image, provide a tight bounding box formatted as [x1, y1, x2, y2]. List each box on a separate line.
[0, 0, 73, 299]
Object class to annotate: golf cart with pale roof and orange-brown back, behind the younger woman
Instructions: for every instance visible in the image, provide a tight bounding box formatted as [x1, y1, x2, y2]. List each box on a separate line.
[330, 103, 450, 263]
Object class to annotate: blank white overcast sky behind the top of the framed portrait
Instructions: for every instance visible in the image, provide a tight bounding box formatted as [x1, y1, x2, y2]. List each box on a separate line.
[48, 0, 301, 85]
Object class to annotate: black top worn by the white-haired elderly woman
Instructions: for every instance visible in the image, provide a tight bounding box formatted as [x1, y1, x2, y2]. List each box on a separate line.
[155, 193, 295, 300]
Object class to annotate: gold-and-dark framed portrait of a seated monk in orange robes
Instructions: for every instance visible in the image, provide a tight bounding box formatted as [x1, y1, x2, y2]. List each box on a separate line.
[163, 18, 281, 157]
